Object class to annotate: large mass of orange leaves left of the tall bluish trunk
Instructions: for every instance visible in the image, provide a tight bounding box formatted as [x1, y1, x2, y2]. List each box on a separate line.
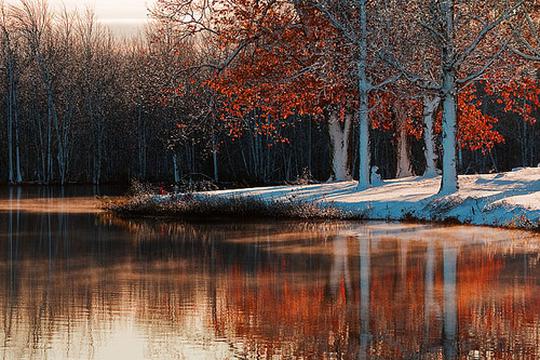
[192, 0, 356, 136]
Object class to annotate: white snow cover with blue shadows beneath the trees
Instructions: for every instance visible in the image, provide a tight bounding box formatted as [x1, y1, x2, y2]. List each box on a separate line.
[207, 168, 540, 228]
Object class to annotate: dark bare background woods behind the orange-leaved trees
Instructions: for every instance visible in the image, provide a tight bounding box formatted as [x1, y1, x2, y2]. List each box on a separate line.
[0, 0, 540, 185]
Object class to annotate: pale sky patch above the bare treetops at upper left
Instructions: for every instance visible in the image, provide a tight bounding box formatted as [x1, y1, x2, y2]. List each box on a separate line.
[8, 0, 155, 35]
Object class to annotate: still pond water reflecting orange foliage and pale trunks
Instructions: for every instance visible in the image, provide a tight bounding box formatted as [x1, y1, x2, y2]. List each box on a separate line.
[0, 188, 540, 360]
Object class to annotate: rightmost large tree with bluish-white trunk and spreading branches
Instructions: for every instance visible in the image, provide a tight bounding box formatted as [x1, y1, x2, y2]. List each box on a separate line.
[383, 0, 522, 195]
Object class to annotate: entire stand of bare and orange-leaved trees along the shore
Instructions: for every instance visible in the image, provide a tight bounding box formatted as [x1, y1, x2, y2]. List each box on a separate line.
[0, 0, 540, 193]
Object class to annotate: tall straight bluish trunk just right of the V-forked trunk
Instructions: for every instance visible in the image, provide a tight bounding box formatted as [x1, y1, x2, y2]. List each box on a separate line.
[357, 0, 371, 190]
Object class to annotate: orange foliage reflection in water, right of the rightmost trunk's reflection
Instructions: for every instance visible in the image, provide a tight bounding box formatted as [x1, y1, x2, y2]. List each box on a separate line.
[457, 249, 540, 359]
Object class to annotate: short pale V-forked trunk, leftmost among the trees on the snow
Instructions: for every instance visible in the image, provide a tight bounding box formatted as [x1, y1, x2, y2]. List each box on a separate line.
[328, 112, 352, 181]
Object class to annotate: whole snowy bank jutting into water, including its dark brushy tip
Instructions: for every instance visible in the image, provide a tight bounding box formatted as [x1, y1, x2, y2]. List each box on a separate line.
[109, 168, 540, 230]
